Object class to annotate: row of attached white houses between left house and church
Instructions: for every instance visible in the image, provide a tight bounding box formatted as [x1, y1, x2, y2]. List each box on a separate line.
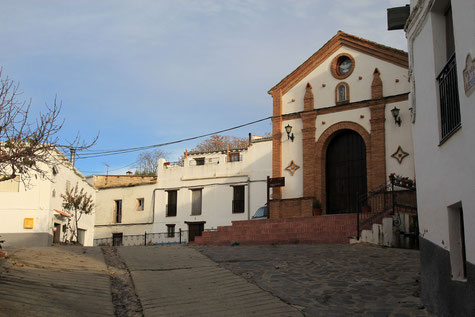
[92, 137, 271, 245]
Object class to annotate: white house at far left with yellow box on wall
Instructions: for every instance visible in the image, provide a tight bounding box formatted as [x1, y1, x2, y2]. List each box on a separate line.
[0, 151, 95, 247]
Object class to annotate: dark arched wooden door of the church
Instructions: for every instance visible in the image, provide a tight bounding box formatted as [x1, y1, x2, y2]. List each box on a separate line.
[325, 130, 367, 214]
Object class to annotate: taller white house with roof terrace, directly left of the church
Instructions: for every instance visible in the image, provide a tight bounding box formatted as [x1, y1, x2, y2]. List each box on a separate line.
[153, 137, 271, 241]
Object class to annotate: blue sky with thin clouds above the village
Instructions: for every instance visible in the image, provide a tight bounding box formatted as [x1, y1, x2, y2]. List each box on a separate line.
[0, 0, 408, 175]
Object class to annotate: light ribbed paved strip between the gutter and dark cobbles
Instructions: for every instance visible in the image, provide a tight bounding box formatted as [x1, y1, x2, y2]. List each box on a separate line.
[119, 246, 302, 316]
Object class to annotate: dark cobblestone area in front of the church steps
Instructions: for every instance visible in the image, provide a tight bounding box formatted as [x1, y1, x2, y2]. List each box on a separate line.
[193, 244, 429, 317]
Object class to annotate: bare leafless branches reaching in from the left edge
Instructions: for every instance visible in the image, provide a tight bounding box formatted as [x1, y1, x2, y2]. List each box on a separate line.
[0, 69, 97, 182]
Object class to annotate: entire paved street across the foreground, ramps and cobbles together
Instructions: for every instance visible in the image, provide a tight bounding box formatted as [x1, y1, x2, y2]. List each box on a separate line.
[0, 244, 429, 317]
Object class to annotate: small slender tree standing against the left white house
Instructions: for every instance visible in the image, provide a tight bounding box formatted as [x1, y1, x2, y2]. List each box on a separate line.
[61, 183, 94, 242]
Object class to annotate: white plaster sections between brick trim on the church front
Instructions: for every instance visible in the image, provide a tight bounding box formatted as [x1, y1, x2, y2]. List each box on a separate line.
[281, 47, 414, 199]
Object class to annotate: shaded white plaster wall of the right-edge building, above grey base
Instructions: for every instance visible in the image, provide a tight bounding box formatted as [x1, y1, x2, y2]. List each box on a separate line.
[410, 1, 475, 263]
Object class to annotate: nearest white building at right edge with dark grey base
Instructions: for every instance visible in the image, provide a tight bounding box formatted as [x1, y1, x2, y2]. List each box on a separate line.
[405, 0, 475, 316]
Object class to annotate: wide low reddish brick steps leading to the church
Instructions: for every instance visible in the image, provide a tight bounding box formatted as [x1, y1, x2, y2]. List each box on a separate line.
[189, 214, 357, 245]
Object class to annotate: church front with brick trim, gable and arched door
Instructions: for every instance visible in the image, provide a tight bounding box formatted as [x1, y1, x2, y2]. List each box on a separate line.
[268, 31, 415, 218]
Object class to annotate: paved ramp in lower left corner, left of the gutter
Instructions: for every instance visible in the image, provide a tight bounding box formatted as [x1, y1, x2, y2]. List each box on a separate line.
[0, 247, 114, 316]
